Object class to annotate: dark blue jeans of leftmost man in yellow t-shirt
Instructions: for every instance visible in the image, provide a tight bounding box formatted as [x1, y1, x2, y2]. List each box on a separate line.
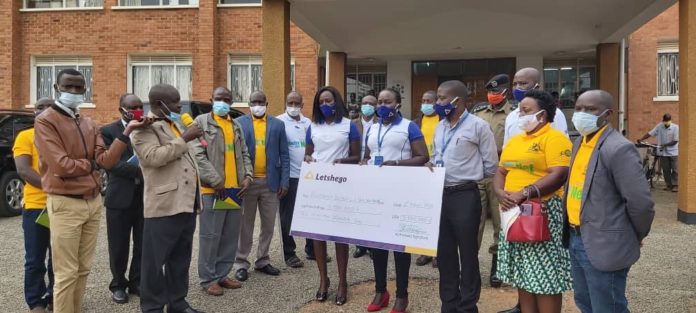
[22, 209, 53, 309]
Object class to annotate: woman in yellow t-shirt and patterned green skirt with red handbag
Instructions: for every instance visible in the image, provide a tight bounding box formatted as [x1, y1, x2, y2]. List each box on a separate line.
[493, 90, 572, 313]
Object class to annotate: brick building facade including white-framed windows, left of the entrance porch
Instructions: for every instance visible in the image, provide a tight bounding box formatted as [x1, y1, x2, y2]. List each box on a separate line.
[0, 0, 319, 123]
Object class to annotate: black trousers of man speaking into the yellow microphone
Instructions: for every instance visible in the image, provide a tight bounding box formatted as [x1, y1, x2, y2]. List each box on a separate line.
[140, 213, 196, 312]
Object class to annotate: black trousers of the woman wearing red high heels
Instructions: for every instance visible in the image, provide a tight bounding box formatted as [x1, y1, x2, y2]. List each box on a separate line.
[370, 249, 411, 298]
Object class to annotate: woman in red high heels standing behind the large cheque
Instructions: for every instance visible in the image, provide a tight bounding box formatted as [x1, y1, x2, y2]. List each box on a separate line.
[360, 89, 428, 313]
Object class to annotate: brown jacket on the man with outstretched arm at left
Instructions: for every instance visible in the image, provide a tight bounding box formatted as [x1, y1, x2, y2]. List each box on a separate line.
[34, 104, 127, 199]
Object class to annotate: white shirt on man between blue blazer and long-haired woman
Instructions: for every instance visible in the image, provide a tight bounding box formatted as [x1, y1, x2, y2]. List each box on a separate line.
[278, 112, 312, 178]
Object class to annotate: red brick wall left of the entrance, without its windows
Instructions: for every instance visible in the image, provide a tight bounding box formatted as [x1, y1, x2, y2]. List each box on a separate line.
[0, 0, 318, 123]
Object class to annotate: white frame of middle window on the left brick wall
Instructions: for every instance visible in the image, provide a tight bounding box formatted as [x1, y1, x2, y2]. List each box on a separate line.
[127, 54, 193, 102]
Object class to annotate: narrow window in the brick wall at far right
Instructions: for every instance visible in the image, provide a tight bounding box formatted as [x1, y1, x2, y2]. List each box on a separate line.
[655, 42, 679, 97]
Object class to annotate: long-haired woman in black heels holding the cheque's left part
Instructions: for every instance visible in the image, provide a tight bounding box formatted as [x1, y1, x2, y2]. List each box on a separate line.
[305, 86, 360, 305]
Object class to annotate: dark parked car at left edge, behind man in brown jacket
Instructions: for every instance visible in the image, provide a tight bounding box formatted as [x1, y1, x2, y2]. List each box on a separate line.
[0, 110, 34, 216]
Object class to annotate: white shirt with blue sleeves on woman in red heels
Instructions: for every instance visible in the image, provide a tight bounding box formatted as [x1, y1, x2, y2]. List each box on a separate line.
[365, 117, 423, 165]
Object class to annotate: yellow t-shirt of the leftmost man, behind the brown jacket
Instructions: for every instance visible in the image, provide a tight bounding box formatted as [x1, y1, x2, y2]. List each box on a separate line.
[12, 128, 46, 210]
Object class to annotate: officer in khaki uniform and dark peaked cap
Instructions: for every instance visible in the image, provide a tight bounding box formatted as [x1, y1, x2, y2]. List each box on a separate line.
[472, 74, 513, 288]
